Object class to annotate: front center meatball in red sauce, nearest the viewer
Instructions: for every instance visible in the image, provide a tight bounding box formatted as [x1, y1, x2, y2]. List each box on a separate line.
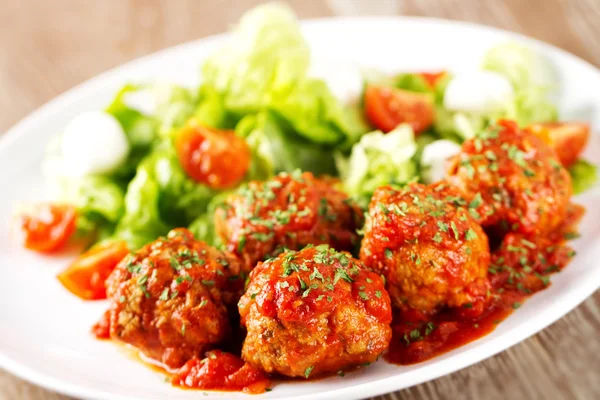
[239, 245, 392, 378]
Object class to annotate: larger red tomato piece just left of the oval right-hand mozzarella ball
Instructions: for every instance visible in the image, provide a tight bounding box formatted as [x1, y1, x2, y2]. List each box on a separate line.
[365, 86, 435, 134]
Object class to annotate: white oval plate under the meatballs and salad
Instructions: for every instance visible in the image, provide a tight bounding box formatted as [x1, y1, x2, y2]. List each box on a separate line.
[0, 17, 600, 400]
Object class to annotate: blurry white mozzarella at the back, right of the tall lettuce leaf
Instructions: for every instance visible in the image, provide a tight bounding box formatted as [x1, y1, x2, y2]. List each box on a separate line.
[308, 57, 364, 103]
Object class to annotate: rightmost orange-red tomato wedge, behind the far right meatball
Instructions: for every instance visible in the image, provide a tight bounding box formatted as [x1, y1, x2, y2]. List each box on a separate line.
[527, 122, 590, 167]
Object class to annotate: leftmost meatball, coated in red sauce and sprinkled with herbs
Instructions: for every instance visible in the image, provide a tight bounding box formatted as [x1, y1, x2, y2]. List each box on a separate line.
[107, 229, 244, 368]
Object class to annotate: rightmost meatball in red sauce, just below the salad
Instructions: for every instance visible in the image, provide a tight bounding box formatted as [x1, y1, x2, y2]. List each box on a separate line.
[448, 121, 571, 235]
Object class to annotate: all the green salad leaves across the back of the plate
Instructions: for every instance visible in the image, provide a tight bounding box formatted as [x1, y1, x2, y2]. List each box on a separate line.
[47, 4, 596, 249]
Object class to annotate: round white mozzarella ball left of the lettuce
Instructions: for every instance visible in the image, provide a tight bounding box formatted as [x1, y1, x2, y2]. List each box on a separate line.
[61, 111, 129, 176]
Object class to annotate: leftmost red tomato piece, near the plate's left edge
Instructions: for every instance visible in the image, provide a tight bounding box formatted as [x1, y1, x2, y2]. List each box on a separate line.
[18, 203, 77, 253]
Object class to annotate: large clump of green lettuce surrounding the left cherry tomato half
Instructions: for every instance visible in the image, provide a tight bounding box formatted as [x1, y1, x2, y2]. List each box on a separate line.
[48, 4, 369, 249]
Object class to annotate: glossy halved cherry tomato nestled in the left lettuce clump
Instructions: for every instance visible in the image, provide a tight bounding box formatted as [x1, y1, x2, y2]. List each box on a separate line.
[175, 119, 251, 189]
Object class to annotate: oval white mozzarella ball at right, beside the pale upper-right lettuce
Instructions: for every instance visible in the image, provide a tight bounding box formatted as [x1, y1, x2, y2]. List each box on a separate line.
[444, 71, 514, 113]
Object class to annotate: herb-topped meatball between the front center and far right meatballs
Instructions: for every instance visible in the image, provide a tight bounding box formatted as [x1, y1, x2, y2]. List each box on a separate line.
[360, 183, 490, 314]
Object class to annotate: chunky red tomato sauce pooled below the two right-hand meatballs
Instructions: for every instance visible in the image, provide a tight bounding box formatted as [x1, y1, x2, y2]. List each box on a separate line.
[384, 205, 584, 365]
